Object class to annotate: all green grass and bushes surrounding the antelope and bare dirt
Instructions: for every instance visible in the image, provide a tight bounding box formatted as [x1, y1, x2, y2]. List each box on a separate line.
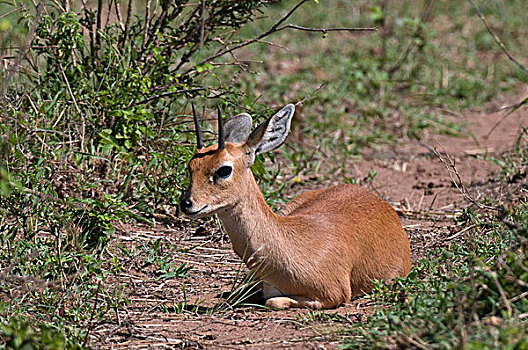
[0, 0, 528, 349]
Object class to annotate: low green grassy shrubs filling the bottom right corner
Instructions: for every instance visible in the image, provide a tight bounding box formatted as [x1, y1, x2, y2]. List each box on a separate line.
[346, 201, 528, 349]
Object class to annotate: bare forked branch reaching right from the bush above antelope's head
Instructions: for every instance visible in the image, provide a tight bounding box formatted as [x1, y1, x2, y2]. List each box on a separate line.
[181, 0, 378, 76]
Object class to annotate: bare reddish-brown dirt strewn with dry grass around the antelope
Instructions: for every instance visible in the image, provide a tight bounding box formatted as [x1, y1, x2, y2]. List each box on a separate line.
[93, 105, 528, 349]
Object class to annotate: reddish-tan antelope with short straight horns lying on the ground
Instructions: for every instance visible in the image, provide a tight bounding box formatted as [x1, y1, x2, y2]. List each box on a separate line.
[180, 104, 411, 309]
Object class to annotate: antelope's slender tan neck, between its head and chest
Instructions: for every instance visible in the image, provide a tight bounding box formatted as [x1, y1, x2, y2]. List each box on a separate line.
[218, 170, 282, 265]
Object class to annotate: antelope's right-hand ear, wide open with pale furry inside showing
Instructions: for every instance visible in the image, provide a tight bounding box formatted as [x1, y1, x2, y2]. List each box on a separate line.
[246, 103, 295, 156]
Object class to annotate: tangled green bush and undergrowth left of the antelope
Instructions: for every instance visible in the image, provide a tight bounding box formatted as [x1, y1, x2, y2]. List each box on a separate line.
[0, 0, 270, 348]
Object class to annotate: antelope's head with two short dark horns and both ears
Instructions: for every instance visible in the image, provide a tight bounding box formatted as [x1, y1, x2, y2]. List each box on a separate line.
[180, 104, 295, 218]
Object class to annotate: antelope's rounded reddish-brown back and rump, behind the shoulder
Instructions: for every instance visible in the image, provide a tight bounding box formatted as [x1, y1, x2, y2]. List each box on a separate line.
[280, 184, 411, 279]
